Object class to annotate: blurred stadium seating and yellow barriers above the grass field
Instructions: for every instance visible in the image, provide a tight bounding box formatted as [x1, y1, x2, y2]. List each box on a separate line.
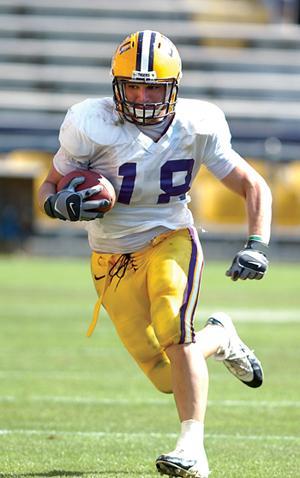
[0, 0, 300, 261]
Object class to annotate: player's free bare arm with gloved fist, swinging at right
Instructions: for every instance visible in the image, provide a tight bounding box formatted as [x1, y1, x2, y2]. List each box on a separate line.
[222, 161, 272, 280]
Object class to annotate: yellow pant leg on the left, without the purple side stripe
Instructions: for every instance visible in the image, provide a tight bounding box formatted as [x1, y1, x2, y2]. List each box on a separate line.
[92, 251, 172, 393]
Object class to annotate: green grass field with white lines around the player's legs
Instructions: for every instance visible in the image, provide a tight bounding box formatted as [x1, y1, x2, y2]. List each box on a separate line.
[0, 256, 300, 478]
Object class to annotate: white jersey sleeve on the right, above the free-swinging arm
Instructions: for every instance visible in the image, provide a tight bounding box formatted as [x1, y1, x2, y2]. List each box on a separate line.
[203, 111, 242, 179]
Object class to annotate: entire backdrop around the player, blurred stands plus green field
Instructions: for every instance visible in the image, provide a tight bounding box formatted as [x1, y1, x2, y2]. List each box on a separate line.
[0, 0, 300, 478]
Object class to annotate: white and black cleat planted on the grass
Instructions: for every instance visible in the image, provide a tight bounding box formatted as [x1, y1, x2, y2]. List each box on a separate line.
[156, 450, 209, 478]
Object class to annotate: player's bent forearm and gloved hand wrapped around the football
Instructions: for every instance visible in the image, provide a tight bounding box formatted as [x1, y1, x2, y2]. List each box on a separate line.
[38, 162, 106, 221]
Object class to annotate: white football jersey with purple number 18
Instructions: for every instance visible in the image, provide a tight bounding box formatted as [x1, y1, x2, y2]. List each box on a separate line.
[54, 98, 241, 253]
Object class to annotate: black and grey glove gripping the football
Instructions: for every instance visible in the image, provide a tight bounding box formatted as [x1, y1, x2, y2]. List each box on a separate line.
[44, 176, 108, 221]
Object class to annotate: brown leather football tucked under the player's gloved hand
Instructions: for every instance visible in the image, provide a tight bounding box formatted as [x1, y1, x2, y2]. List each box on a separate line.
[57, 169, 116, 212]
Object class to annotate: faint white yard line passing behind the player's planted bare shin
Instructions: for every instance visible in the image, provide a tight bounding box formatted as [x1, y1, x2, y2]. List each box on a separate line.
[0, 395, 300, 408]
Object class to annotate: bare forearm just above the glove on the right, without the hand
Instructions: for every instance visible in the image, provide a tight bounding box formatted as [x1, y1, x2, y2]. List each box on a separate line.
[245, 178, 272, 244]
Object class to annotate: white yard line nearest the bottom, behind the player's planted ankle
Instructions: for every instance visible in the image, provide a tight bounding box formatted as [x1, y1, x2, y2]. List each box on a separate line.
[0, 429, 300, 441]
